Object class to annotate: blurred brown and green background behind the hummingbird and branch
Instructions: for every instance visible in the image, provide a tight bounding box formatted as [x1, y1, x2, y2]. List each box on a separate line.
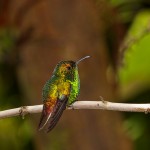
[0, 0, 150, 150]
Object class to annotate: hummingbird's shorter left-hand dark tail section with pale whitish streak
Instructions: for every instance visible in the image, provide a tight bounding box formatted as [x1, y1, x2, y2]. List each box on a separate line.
[38, 106, 51, 131]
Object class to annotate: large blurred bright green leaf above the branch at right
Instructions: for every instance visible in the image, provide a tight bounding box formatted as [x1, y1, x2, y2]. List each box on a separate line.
[119, 11, 150, 95]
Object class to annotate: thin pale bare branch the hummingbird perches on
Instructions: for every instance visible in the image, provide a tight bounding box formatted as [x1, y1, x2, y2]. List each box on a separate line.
[0, 101, 150, 119]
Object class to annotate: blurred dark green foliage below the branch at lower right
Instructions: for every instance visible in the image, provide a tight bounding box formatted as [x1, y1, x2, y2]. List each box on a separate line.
[124, 113, 150, 150]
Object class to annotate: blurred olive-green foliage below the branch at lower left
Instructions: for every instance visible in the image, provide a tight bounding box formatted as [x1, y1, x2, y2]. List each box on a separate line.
[0, 118, 32, 150]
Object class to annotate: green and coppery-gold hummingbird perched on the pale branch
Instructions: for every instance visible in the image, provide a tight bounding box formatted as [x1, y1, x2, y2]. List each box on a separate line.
[38, 56, 90, 133]
